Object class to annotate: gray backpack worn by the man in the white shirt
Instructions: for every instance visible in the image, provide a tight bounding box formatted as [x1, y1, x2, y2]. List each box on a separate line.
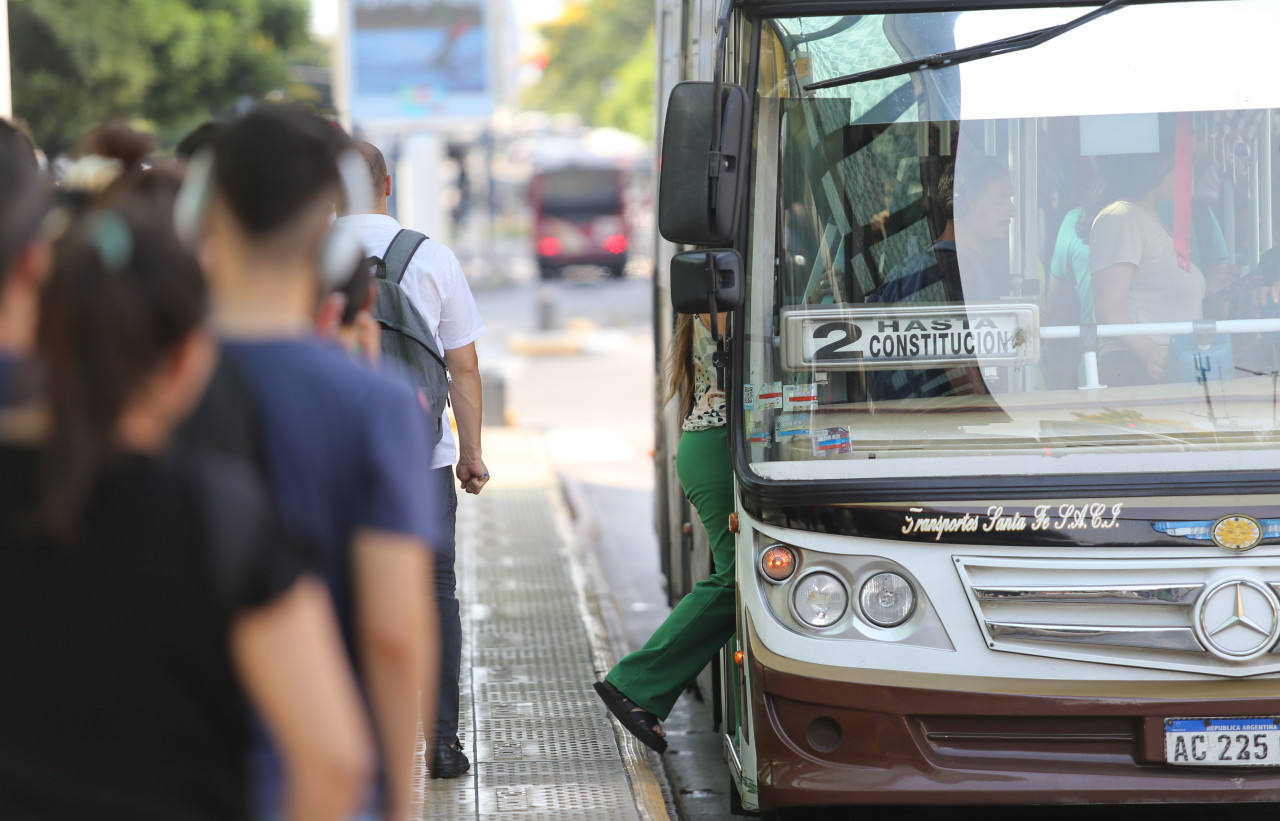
[365, 229, 449, 442]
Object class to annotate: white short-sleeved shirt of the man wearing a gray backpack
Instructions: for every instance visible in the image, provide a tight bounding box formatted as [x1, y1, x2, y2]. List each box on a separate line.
[340, 214, 485, 469]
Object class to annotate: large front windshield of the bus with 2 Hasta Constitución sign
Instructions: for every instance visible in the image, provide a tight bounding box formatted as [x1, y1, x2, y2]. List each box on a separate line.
[742, 0, 1280, 480]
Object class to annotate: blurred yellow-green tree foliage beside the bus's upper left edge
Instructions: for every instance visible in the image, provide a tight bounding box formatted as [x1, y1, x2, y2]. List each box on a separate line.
[525, 0, 657, 138]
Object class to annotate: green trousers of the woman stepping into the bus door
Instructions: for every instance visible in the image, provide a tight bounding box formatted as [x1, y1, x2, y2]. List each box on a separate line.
[604, 428, 735, 719]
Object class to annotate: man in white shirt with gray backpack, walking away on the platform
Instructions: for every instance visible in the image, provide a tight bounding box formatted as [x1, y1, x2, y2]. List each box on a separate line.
[338, 142, 489, 779]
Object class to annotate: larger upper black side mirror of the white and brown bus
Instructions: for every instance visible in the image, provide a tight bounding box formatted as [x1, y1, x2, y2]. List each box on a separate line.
[658, 82, 748, 245]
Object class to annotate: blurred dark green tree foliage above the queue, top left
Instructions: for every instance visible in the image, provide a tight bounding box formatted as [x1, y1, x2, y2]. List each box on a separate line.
[9, 0, 310, 152]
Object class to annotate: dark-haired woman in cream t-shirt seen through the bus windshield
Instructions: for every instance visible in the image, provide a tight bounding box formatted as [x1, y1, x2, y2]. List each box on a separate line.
[1079, 154, 1204, 386]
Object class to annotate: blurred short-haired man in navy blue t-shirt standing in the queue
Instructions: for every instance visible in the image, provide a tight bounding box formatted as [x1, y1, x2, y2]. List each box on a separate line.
[175, 106, 438, 820]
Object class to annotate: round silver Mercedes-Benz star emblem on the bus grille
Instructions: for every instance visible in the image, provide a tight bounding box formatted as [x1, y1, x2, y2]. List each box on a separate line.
[1194, 579, 1280, 661]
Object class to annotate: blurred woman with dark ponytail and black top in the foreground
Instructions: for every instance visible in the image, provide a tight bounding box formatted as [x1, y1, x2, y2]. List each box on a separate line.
[0, 202, 370, 821]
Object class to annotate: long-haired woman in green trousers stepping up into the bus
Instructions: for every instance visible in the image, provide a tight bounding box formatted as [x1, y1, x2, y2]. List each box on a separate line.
[594, 314, 735, 753]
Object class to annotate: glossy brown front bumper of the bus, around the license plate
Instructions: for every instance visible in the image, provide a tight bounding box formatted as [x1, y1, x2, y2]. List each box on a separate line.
[748, 621, 1280, 809]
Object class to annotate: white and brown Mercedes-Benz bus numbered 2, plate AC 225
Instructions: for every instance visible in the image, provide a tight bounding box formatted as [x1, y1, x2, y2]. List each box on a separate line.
[655, 0, 1280, 812]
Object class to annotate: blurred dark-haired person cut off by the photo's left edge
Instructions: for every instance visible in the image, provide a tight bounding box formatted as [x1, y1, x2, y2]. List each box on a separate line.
[0, 119, 52, 406]
